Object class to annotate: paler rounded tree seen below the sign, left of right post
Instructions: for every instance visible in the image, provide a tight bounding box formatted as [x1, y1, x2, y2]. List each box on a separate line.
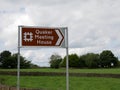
[49, 53, 62, 68]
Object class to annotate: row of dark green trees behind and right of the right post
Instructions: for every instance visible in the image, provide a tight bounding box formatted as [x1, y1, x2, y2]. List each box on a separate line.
[60, 50, 120, 68]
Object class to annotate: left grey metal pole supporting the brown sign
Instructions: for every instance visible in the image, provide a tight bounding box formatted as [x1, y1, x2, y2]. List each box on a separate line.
[17, 26, 20, 90]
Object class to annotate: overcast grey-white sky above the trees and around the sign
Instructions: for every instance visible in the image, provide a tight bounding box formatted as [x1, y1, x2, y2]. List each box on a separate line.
[0, 0, 120, 66]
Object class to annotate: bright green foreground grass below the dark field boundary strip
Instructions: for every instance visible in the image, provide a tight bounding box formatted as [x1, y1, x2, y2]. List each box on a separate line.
[0, 75, 120, 90]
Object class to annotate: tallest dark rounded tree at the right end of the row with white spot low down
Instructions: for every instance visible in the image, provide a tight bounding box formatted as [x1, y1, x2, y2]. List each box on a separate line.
[100, 50, 119, 67]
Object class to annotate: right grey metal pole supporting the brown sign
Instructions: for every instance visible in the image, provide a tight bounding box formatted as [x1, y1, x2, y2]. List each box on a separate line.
[66, 28, 69, 90]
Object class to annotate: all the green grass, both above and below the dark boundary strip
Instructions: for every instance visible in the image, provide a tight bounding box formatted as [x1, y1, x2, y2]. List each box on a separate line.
[0, 68, 120, 90]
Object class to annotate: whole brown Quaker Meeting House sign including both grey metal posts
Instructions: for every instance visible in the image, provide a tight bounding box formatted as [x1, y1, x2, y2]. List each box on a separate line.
[17, 26, 69, 90]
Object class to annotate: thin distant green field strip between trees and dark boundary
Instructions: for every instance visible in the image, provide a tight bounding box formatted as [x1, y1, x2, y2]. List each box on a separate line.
[0, 68, 120, 74]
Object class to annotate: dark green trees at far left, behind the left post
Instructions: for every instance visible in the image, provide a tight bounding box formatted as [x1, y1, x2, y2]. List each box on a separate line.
[0, 51, 32, 68]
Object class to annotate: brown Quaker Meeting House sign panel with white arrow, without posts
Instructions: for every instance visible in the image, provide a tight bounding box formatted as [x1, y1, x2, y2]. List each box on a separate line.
[21, 27, 65, 46]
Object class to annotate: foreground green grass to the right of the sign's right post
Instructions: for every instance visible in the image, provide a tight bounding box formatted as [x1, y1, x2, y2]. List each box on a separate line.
[70, 77, 120, 90]
